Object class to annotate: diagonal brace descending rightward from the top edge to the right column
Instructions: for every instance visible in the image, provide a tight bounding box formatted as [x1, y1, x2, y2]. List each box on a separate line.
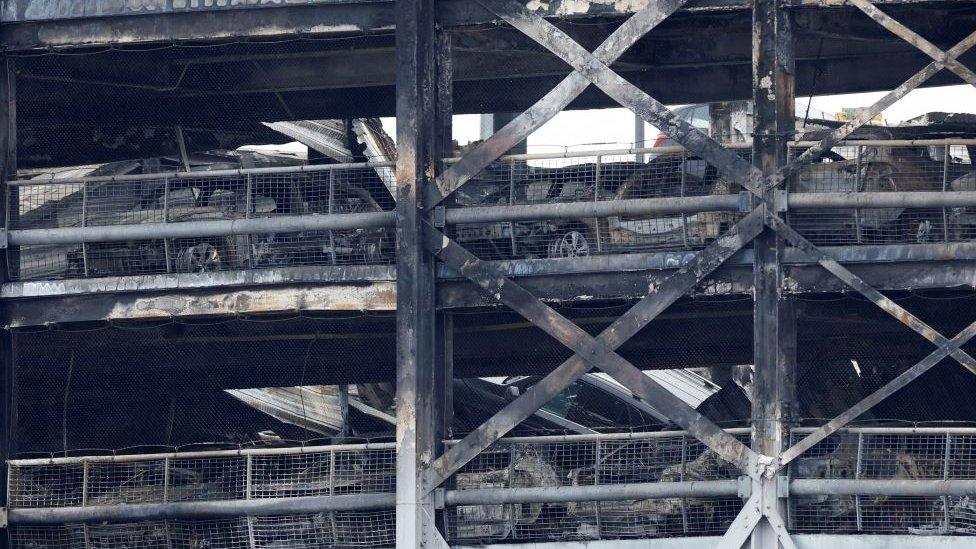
[478, 0, 764, 195]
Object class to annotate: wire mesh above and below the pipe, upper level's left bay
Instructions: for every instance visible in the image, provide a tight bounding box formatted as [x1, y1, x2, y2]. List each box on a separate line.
[8, 163, 396, 280]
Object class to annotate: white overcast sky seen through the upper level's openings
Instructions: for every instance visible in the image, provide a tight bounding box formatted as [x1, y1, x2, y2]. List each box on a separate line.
[383, 85, 976, 153]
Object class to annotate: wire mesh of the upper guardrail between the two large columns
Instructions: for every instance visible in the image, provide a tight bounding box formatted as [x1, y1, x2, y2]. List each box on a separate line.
[449, 147, 750, 259]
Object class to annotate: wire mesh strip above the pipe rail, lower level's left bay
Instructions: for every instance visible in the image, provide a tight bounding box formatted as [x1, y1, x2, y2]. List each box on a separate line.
[8, 443, 396, 508]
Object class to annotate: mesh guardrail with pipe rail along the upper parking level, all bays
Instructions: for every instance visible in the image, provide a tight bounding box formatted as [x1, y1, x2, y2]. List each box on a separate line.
[7, 140, 976, 280]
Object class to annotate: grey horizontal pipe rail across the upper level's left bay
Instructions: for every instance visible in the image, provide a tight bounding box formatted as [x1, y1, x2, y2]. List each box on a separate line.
[7, 211, 395, 246]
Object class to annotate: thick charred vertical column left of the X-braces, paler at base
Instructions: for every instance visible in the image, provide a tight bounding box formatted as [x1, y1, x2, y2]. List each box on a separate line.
[396, 0, 449, 549]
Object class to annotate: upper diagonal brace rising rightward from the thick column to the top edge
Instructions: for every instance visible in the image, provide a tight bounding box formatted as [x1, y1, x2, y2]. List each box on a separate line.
[424, 0, 687, 208]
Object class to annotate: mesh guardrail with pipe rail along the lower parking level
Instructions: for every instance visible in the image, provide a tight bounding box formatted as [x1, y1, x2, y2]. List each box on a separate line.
[8, 428, 976, 547]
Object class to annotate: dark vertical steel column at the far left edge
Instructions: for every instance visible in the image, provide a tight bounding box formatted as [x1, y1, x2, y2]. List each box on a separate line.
[0, 56, 20, 548]
